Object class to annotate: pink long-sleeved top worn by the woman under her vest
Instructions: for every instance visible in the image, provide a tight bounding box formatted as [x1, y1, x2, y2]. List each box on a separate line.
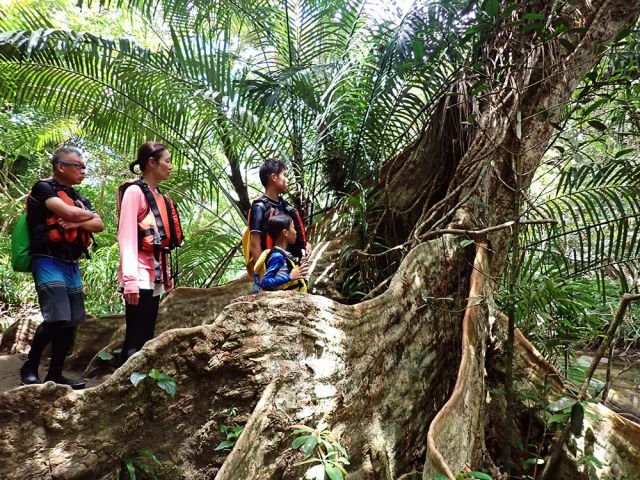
[118, 185, 170, 295]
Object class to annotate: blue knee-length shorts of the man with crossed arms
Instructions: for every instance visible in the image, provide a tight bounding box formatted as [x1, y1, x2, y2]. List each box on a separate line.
[31, 256, 85, 325]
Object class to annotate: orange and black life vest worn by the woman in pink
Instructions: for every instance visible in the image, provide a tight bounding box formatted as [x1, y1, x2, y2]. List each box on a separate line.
[116, 179, 184, 286]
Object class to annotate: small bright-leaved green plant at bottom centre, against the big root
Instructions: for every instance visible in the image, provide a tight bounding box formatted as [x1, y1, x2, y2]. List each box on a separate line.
[291, 422, 349, 480]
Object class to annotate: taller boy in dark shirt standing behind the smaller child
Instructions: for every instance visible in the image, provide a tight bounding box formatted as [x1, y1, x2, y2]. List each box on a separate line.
[248, 159, 311, 293]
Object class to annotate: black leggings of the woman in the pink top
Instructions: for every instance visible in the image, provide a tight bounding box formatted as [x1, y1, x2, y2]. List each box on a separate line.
[120, 290, 160, 363]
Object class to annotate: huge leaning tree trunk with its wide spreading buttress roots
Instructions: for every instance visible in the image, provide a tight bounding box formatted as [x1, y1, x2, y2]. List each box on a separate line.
[0, 0, 640, 480]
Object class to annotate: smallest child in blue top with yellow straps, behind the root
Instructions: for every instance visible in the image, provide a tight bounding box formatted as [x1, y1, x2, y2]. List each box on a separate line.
[254, 215, 309, 292]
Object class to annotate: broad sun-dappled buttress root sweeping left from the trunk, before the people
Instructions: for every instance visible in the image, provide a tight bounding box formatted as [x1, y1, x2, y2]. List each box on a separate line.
[0, 238, 470, 479]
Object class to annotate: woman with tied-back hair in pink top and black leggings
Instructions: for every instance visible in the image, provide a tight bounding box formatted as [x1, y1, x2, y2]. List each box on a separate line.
[118, 141, 182, 363]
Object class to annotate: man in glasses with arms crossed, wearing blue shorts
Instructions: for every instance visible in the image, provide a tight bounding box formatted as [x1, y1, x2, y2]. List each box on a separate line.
[20, 147, 104, 389]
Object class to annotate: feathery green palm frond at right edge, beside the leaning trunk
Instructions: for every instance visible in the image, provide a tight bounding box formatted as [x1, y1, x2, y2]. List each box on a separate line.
[523, 160, 640, 282]
